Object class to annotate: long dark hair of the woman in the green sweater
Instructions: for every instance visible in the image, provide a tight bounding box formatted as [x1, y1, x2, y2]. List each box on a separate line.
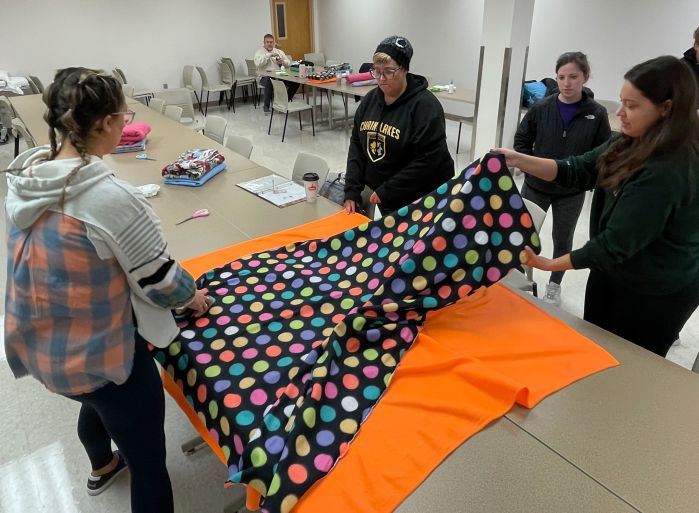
[598, 55, 699, 191]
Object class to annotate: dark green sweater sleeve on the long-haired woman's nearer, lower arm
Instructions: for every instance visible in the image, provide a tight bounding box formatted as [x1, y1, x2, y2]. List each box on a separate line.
[570, 163, 680, 271]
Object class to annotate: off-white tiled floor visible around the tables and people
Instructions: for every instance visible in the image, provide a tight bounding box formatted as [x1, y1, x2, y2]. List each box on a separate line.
[0, 93, 699, 513]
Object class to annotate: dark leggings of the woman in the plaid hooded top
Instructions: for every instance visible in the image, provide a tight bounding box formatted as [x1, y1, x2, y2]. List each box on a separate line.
[69, 334, 173, 513]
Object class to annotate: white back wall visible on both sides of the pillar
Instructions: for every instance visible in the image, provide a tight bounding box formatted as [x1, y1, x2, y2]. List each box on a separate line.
[318, 0, 699, 103]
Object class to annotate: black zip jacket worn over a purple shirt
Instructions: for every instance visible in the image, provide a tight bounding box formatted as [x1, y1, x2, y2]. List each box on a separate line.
[514, 91, 612, 196]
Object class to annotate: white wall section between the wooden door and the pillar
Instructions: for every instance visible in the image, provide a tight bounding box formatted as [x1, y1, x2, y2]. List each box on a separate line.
[316, 0, 483, 88]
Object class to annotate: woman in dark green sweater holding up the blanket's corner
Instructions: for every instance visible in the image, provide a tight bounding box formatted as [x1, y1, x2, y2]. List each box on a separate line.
[499, 56, 699, 356]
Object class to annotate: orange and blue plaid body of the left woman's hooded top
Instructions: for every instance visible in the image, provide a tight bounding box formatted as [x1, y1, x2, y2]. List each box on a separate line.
[5, 212, 135, 395]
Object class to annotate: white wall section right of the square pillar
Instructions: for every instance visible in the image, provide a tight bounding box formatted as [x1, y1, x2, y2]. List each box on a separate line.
[527, 0, 699, 100]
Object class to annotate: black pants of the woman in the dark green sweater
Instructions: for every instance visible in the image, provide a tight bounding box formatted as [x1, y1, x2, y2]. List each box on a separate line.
[585, 271, 699, 356]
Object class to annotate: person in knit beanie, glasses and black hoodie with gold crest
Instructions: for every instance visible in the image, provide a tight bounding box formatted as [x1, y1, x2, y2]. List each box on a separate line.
[345, 36, 454, 213]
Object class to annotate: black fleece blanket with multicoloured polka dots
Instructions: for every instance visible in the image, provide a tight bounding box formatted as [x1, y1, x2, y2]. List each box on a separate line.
[155, 154, 539, 513]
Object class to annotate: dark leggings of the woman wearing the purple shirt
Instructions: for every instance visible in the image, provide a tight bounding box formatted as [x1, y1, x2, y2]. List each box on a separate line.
[522, 183, 585, 285]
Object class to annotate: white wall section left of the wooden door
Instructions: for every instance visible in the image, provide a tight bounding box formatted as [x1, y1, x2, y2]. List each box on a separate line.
[0, 0, 271, 89]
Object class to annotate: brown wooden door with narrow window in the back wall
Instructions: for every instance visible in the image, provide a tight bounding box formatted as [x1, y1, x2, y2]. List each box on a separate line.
[269, 0, 313, 61]
